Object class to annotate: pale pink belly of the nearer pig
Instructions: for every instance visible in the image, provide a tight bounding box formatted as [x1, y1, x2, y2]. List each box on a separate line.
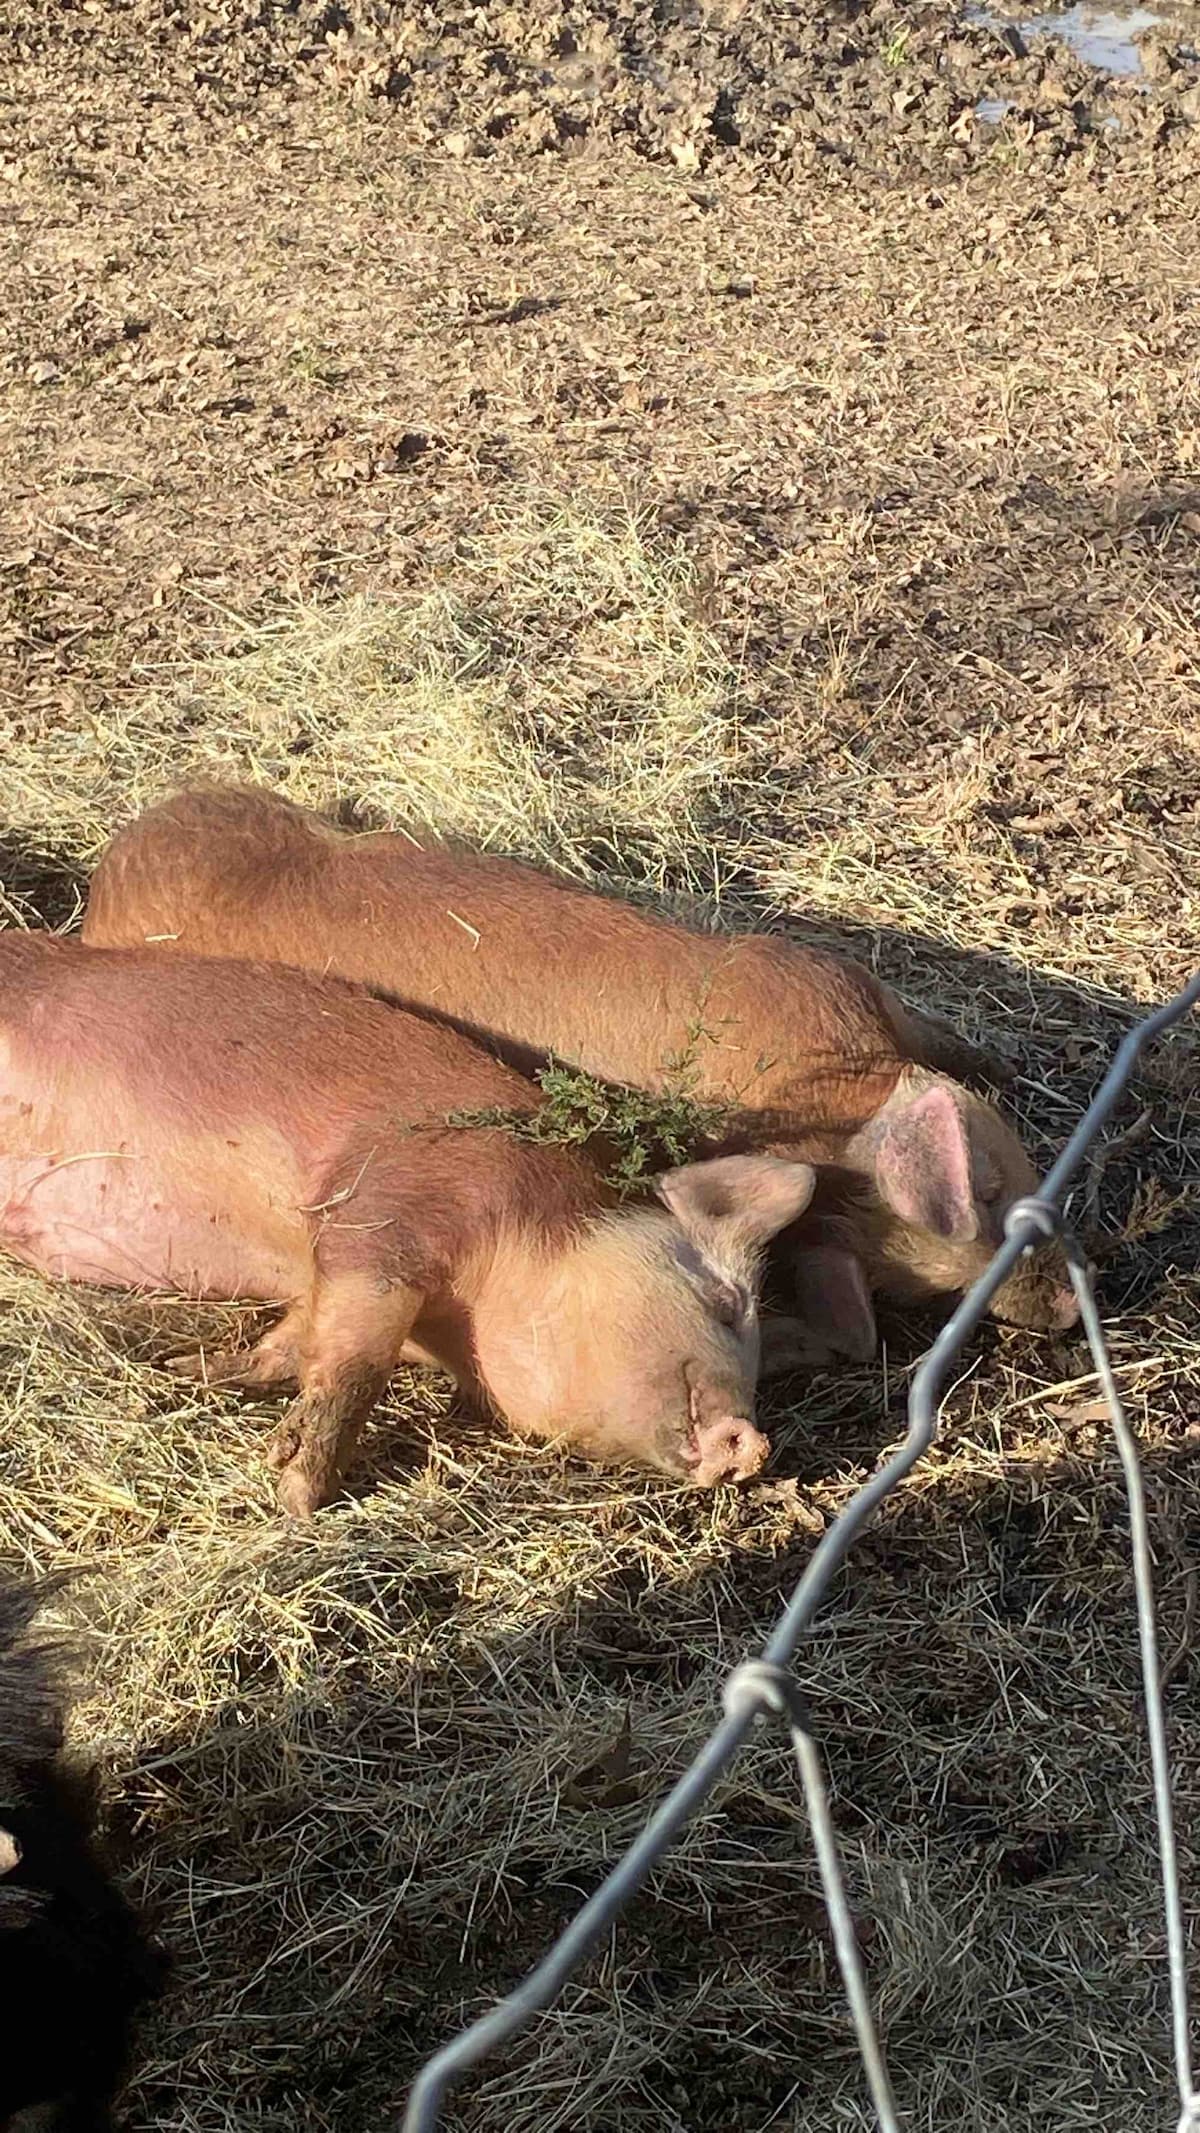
[0, 1152, 307, 1303]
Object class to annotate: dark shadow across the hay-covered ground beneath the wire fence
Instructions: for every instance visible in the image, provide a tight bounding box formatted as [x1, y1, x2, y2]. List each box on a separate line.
[77, 1429, 1200, 2133]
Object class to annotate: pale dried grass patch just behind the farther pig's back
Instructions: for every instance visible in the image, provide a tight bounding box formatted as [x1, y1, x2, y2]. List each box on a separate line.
[6, 497, 740, 900]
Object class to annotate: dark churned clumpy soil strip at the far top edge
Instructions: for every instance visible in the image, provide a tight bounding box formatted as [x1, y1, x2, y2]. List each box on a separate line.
[11, 0, 1200, 177]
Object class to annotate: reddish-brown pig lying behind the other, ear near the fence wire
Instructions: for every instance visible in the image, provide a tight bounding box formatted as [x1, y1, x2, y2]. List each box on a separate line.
[83, 787, 1076, 1367]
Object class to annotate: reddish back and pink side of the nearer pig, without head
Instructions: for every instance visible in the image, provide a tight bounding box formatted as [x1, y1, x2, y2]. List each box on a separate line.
[0, 934, 603, 1299]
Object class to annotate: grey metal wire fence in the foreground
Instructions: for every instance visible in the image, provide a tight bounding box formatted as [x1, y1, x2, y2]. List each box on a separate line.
[403, 971, 1200, 2133]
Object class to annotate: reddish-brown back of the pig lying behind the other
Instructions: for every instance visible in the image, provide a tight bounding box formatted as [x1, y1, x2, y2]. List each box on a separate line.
[85, 787, 902, 1139]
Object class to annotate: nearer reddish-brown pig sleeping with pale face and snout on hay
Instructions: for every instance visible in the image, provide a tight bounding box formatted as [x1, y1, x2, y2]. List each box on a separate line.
[0, 932, 812, 1517]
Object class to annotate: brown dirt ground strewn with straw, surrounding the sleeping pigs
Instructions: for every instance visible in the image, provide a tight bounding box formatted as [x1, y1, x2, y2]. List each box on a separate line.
[0, 0, 1200, 2133]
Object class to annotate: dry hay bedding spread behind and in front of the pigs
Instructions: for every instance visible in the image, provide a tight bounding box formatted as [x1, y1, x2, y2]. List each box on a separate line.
[0, 501, 1200, 2133]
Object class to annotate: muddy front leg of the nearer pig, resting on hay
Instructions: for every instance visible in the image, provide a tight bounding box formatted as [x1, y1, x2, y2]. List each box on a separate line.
[266, 1273, 424, 1519]
